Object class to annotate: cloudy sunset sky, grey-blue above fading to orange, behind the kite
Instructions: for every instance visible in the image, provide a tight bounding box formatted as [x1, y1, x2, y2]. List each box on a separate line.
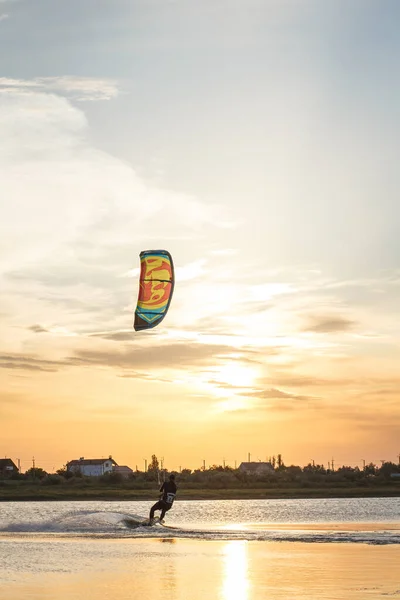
[0, 0, 400, 470]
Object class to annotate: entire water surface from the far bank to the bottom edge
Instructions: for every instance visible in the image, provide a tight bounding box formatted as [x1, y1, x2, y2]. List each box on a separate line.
[0, 498, 400, 600]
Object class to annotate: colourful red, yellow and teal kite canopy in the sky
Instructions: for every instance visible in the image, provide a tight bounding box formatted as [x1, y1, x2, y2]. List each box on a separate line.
[134, 250, 175, 331]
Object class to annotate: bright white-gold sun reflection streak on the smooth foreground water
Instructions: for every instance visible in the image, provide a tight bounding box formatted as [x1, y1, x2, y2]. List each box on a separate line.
[222, 540, 249, 600]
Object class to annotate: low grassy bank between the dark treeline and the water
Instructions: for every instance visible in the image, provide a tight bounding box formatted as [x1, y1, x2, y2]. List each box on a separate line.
[0, 484, 400, 501]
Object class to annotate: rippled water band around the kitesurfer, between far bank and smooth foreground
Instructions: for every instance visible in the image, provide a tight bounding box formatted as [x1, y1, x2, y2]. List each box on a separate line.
[0, 498, 400, 544]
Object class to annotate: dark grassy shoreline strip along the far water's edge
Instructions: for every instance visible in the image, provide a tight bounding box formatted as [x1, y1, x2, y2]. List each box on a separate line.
[0, 486, 400, 502]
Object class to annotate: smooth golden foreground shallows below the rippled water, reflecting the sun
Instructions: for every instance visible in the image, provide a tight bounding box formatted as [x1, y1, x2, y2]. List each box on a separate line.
[0, 537, 400, 600]
